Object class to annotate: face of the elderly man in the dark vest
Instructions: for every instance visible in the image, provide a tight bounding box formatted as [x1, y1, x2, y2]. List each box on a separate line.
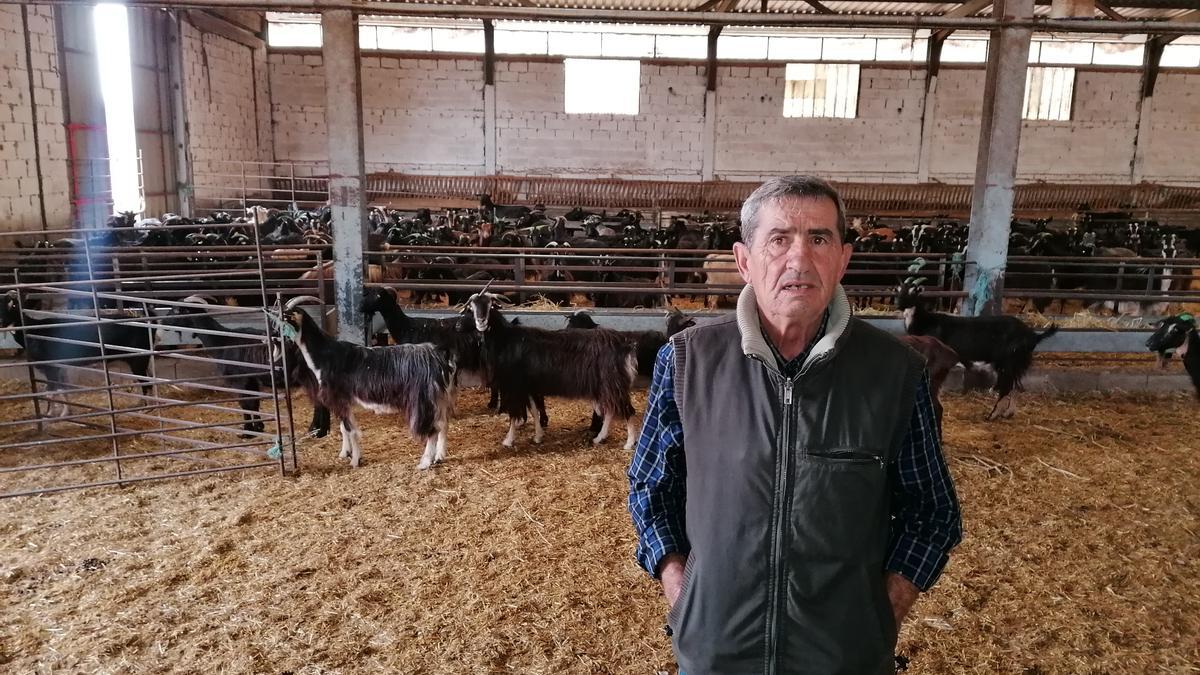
[733, 197, 852, 324]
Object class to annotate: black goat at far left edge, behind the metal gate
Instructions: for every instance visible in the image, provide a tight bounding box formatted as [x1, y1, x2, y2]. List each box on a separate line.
[0, 291, 151, 417]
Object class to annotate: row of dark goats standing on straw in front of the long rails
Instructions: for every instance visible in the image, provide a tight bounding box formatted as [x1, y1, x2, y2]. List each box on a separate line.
[0, 279, 1200, 470]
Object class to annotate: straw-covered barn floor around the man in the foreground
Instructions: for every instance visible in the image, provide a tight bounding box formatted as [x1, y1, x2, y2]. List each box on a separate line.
[0, 381, 1200, 674]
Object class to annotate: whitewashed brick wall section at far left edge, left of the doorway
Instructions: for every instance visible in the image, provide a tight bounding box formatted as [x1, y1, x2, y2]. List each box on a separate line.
[0, 6, 71, 232]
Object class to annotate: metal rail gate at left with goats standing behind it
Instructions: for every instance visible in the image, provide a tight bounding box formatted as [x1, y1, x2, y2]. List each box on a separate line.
[0, 223, 314, 497]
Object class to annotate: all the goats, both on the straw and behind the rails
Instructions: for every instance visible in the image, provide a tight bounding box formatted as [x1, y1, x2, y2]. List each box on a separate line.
[0, 196, 1200, 468]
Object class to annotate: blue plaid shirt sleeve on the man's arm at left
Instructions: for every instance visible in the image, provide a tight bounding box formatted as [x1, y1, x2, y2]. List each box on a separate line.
[628, 341, 691, 578]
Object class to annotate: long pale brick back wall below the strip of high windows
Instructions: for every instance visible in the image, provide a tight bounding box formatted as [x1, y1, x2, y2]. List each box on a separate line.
[270, 53, 1200, 183]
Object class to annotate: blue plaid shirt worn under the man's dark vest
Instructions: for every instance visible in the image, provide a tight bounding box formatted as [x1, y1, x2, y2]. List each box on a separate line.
[629, 331, 962, 591]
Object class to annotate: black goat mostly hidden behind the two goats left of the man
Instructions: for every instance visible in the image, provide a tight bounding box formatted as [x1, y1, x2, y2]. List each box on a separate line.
[362, 288, 550, 425]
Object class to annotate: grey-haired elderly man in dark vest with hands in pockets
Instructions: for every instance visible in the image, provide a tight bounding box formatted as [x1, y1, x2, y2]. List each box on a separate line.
[629, 177, 961, 675]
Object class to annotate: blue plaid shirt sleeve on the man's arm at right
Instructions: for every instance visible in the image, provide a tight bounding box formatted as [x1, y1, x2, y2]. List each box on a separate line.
[887, 372, 962, 591]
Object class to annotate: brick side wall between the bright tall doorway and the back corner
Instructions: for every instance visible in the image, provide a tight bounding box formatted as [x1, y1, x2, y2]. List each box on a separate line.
[182, 22, 274, 208]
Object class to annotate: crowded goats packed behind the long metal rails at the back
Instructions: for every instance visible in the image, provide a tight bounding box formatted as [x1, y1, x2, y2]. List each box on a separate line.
[9, 195, 1200, 315]
